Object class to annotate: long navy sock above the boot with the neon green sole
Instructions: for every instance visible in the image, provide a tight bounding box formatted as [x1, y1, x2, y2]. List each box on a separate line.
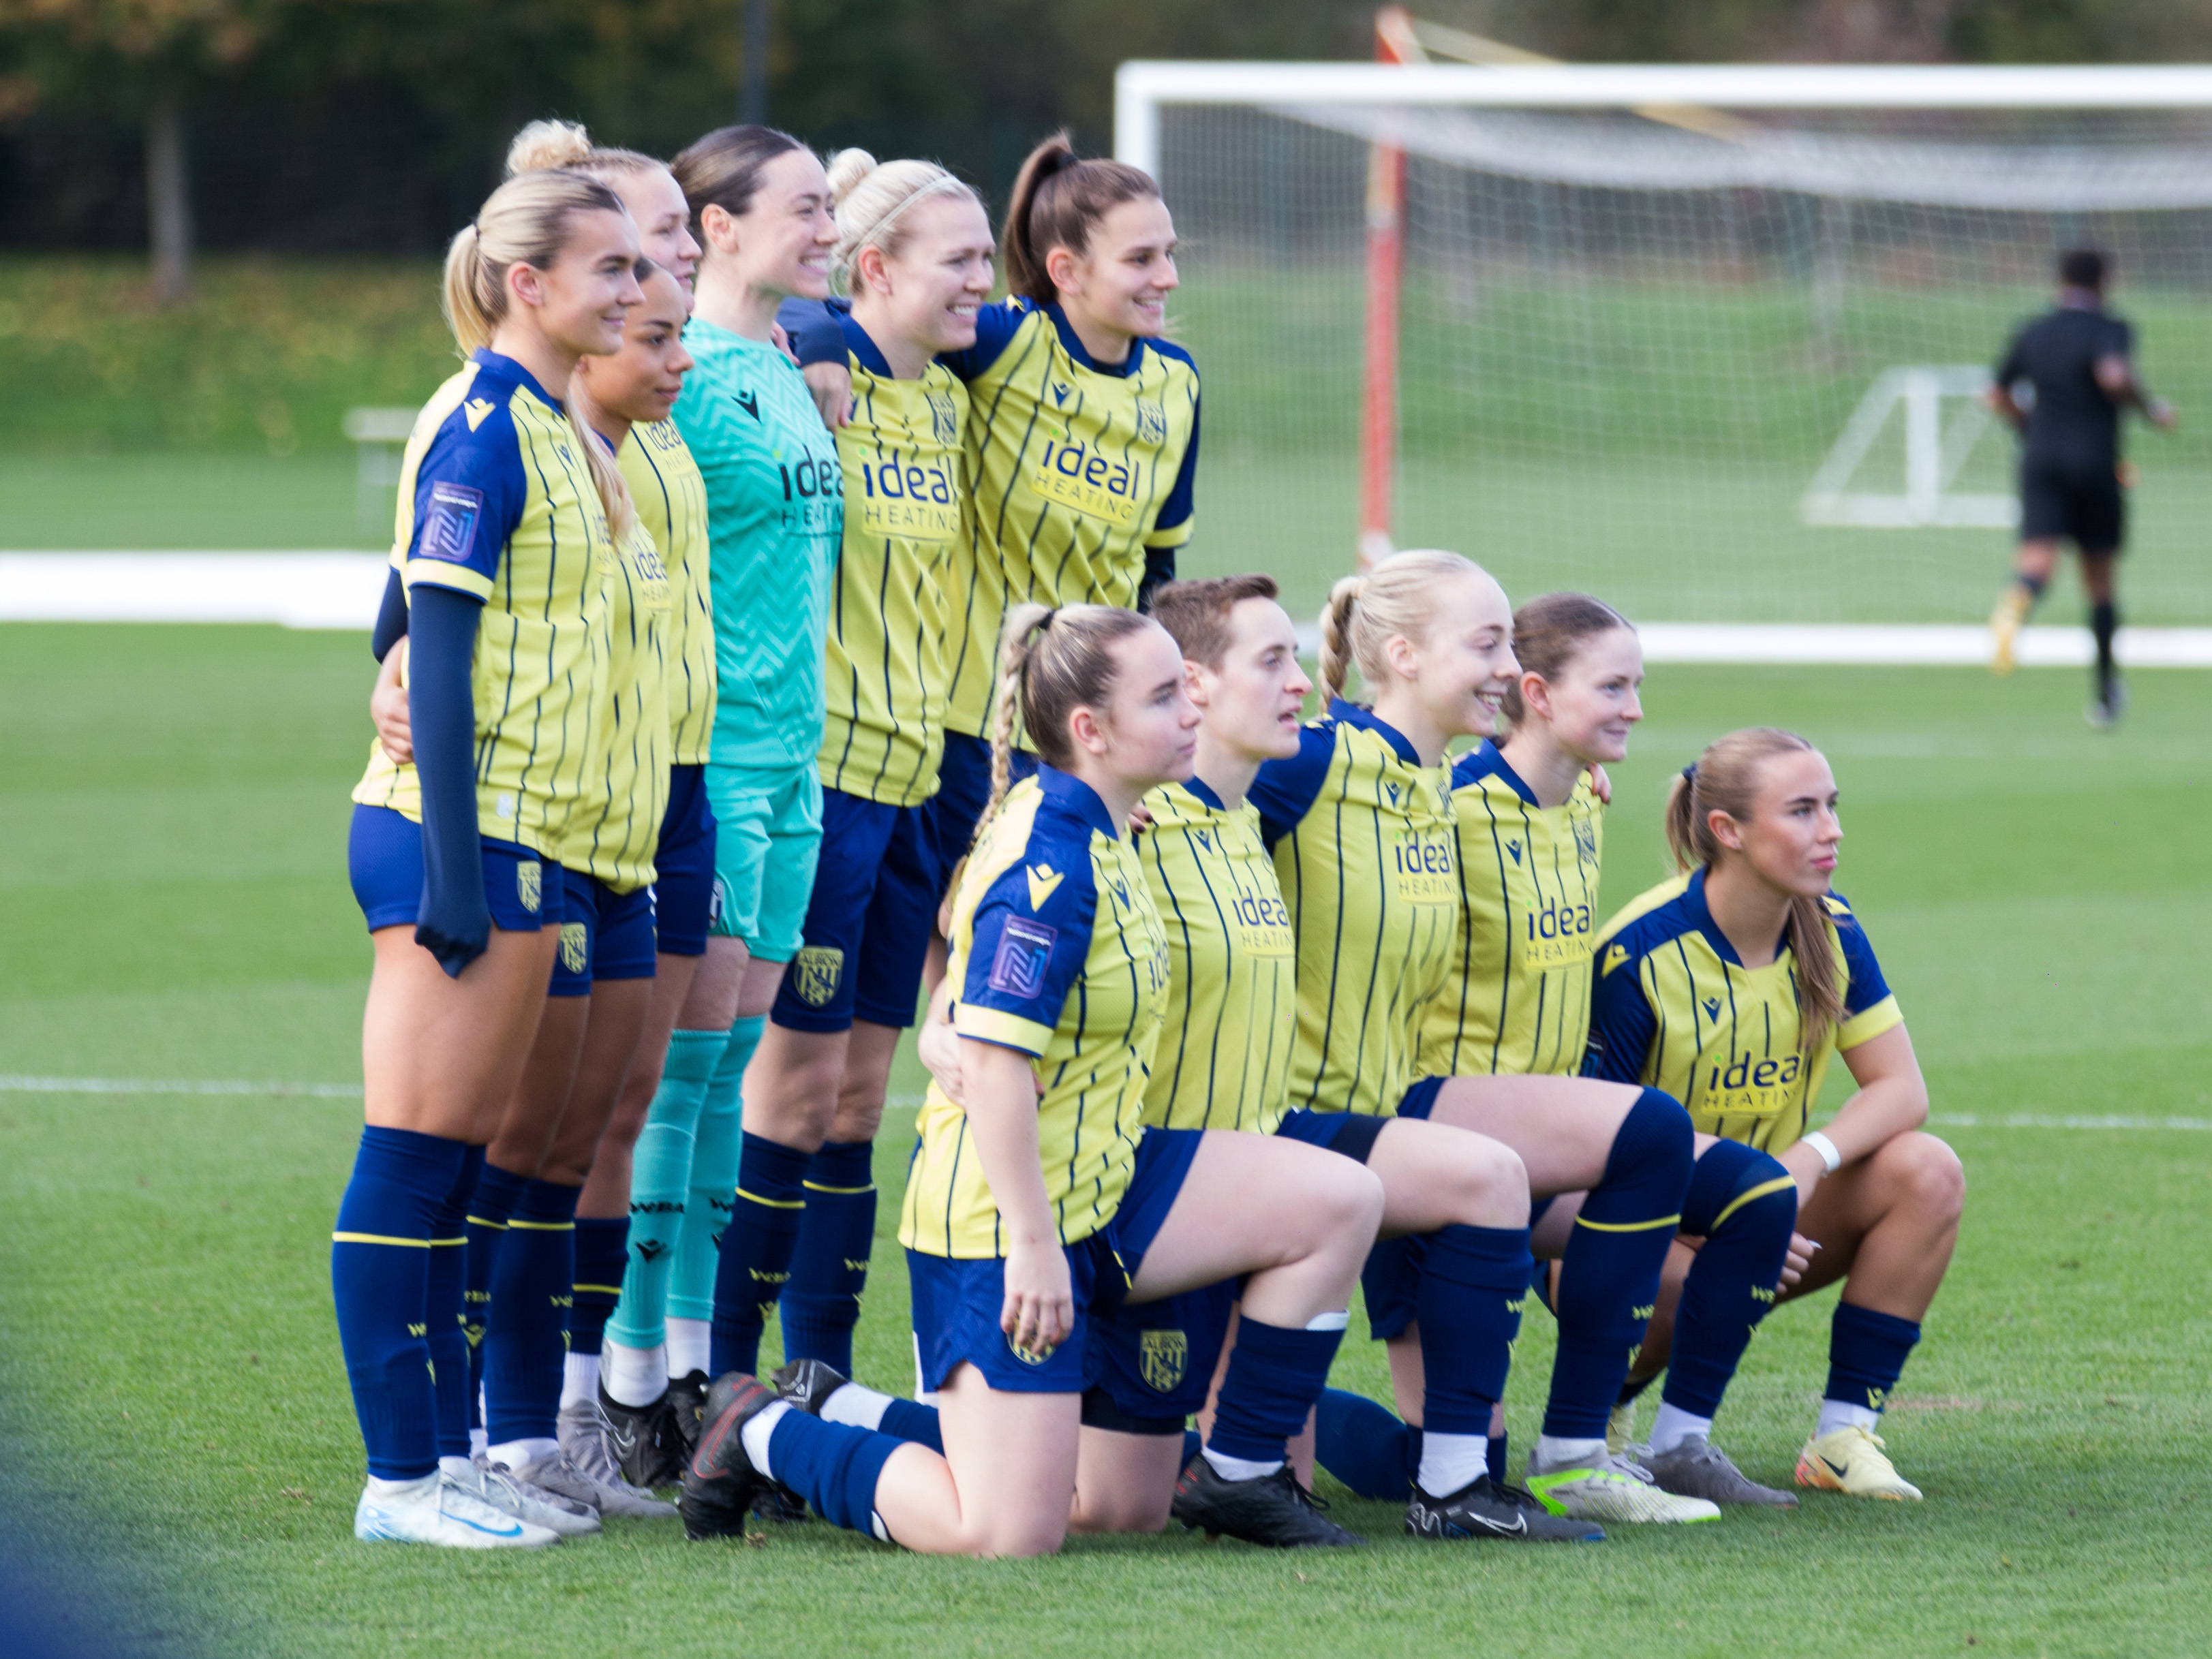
[1544, 1088, 1694, 1440]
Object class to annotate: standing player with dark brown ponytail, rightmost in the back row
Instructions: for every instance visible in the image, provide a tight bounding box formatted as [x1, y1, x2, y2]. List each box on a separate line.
[785, 133, 1199, 863]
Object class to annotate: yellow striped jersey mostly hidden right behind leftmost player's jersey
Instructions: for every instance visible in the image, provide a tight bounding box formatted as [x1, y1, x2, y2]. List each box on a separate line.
[557, 506, 671, 894]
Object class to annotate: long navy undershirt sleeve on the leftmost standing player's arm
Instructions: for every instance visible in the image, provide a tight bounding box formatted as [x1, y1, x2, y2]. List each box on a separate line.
[407, 582, 491, 980]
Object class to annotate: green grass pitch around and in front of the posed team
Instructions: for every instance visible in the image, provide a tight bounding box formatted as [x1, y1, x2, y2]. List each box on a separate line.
[0, 626, 2212, 1659]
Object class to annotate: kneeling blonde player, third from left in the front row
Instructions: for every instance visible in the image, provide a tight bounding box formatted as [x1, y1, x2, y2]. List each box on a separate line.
[1257, 553, 1719, 1522]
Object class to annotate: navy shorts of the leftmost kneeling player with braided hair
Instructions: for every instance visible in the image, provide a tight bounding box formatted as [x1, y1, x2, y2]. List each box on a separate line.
[907, 1128, 1219, 1400]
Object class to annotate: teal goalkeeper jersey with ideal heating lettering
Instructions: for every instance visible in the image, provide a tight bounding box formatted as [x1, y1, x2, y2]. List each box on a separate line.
[675, 316, 845, 768]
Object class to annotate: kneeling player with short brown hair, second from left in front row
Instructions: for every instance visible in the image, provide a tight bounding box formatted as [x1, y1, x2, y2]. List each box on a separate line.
[1077, 575, 1603, 1540]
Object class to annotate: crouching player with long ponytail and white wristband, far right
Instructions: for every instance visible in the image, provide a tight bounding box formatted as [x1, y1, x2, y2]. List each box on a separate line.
[1586, 728, 1967, 1498]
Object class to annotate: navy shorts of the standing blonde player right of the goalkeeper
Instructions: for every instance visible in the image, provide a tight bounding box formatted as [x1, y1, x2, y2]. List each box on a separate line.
[770, 790, 944, 1031]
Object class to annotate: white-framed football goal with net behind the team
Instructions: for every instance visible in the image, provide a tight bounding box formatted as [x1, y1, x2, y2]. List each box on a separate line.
[1117, 64, 2212, 621]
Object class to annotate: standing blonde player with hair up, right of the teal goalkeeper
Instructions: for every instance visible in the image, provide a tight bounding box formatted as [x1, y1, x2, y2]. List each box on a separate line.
[717, 151, 991, 1406]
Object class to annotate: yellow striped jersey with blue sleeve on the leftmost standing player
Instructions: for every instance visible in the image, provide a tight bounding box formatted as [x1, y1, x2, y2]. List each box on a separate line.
[354, 352, 615, 858]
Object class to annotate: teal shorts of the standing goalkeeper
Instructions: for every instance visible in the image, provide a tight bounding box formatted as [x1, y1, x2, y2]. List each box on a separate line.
[705, 761, 823, 962]
